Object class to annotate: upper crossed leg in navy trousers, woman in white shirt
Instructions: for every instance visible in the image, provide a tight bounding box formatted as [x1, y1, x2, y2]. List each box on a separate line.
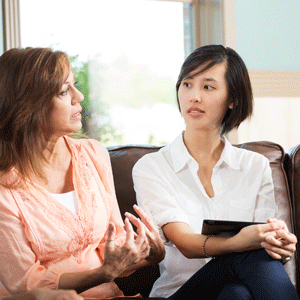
[170, 249, 299, 299]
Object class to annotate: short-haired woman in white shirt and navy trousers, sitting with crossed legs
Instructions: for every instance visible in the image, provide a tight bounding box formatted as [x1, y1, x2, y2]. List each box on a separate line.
[133, 45, 298, 300]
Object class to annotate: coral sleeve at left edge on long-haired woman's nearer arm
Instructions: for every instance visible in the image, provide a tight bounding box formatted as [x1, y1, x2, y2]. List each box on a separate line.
[0, 187, 61, 294]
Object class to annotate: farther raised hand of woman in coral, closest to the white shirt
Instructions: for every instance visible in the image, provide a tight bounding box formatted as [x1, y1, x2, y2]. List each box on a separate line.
[126, 205, 165, 263]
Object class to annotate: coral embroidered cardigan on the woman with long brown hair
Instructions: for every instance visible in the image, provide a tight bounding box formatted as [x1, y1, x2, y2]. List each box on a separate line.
[0, 137, 125, 298]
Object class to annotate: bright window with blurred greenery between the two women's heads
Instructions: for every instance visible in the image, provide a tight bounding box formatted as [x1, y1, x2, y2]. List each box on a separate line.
[20, 0, 186, 145]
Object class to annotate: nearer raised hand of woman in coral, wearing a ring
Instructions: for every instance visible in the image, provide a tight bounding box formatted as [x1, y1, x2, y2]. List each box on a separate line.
[103, 218, 150, 280]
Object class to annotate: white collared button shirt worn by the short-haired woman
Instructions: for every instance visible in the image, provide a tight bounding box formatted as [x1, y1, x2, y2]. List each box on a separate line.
[133, 134, 277, 297]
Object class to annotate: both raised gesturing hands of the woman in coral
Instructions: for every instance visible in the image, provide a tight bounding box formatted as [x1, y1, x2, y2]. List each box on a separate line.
[103, 205, 165, 278]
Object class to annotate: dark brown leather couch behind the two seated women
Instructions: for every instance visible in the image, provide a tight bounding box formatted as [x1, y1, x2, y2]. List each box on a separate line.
[108, 142, 300, 298]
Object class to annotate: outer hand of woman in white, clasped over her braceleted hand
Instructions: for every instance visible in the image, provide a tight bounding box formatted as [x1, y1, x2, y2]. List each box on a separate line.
[261, 218, 297, 260]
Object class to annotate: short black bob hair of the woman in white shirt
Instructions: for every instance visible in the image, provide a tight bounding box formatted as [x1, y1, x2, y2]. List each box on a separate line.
[176, 45, 253, 134]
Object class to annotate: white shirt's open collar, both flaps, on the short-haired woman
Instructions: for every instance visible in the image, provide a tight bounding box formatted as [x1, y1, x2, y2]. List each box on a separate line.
[170, 132, 240, 173]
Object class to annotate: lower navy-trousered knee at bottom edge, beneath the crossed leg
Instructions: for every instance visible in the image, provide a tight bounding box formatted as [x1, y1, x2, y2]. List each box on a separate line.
[217, 283, 254, 300]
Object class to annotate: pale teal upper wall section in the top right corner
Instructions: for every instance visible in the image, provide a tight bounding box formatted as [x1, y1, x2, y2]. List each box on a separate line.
[235, 0, 300, 70]
